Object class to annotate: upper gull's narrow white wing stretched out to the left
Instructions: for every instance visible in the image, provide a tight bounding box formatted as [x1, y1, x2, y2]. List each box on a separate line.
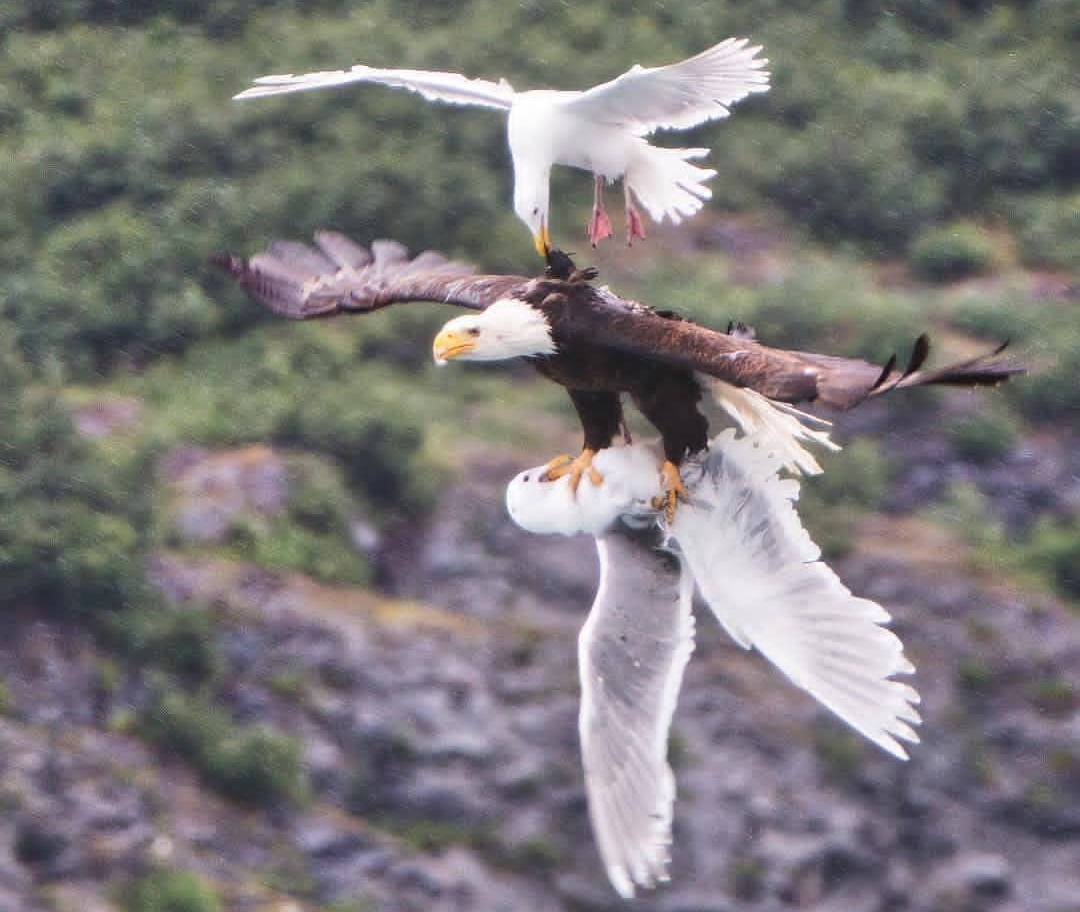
[233, 64, 514, 110]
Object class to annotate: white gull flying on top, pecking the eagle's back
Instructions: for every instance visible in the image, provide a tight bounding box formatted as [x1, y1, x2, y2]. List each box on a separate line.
[234, 38, 769, 256]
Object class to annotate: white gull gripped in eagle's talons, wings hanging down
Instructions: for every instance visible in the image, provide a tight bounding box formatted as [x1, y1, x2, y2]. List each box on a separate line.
[507, 429, 920, 898]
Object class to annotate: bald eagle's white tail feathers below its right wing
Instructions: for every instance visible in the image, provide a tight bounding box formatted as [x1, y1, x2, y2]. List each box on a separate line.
[700, 376, 840, 475]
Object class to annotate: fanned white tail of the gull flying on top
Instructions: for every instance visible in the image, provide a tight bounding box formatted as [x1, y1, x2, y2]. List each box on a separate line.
[623, 139, 716, 225]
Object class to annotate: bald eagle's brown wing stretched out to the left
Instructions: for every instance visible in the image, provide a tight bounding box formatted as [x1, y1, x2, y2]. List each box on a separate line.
[213, 231, 526, 320]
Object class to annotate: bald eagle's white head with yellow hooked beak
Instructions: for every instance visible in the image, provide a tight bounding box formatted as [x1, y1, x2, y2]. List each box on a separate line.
[431, 298, 555, 364]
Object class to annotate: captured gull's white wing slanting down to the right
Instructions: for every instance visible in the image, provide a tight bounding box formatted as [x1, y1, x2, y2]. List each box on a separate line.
[672, 430, 920, 759]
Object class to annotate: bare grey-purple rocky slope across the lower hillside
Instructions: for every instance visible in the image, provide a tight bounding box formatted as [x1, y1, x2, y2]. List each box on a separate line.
[0, 410, 1080, 912]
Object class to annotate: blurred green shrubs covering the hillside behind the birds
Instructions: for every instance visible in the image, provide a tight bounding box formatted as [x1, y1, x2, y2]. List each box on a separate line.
[0, 0, 1080, 816]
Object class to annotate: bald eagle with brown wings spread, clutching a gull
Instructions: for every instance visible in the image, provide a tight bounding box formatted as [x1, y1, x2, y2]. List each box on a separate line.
[214, 231, 1024, 520]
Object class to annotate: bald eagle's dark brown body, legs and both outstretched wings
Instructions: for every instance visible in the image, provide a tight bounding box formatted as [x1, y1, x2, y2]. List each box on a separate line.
[214, 231, 1025, 451]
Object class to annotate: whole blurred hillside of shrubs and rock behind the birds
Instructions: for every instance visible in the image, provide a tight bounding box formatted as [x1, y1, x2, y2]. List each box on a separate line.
[0, 0, 1080, 912]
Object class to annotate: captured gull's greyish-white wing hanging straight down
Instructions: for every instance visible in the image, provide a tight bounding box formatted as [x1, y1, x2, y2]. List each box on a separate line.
[578, 527, 693, 897]
